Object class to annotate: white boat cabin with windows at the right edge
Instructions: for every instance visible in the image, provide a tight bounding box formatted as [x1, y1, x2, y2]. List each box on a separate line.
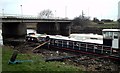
[102, 29, 120, 49]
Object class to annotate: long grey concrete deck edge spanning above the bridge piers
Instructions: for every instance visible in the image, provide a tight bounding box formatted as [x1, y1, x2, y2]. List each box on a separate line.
[0, 17, 72, 23]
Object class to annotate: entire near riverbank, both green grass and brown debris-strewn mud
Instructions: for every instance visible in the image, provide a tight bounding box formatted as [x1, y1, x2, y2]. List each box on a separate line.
[2, 44, 120, 73]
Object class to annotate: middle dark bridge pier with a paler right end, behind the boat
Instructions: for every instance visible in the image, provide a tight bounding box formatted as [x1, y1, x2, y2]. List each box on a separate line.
[37, 22, 60, 35]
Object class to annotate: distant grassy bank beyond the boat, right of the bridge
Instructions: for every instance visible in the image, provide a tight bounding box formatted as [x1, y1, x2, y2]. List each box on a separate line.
[72, 22, 118, 35]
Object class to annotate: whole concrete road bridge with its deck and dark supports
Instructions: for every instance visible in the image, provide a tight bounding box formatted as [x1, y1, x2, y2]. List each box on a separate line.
[0, 16, 72, 44]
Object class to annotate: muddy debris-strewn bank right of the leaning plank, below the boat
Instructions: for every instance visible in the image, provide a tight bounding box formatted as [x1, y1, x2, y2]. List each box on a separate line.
[34, 49, 120, 71]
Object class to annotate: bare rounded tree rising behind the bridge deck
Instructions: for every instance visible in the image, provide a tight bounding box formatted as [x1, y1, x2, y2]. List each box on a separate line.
[39, 9, 53, 19]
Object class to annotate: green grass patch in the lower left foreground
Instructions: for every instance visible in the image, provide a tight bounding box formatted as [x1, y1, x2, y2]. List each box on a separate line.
[2, 48, 82, 72]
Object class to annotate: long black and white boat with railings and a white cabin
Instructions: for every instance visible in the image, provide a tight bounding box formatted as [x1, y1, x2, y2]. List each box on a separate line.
[26, 29, 120, 60]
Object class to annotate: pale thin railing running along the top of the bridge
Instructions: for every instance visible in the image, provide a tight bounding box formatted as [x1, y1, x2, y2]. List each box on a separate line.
[0, 14, 71, 22]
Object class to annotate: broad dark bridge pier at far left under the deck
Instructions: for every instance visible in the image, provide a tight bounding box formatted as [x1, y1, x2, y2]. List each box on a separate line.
[2, 22, 27, 46]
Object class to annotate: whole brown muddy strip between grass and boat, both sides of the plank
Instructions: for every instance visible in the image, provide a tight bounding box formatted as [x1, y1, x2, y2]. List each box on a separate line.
[11, 43, 120, 71]
